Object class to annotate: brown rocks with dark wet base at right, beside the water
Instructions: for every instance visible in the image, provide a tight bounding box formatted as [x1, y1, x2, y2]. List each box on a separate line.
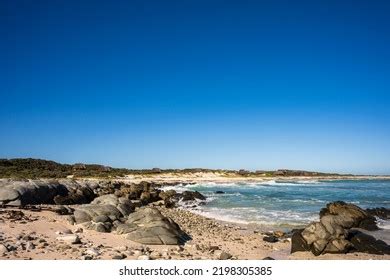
[291, 201, 390, 256]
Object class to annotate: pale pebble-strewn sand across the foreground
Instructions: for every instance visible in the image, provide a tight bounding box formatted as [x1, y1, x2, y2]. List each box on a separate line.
[0, 208, 390, 260]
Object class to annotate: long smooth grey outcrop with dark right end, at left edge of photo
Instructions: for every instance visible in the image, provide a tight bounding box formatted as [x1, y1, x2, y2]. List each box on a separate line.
[0, 180, 95, 206]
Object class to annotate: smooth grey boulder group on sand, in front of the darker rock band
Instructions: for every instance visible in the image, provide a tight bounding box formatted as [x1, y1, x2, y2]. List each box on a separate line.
[70, 194, 189, 245]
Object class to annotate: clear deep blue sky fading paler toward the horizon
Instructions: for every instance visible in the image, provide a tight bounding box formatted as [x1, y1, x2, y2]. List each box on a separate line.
[0, 0, 390, 174]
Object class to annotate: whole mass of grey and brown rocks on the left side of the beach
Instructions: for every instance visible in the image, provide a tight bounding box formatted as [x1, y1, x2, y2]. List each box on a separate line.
[0, 179, 210, 245]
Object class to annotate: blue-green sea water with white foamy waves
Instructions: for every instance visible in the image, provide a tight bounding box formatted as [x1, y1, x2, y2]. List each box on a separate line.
[166, 180, 390, 229]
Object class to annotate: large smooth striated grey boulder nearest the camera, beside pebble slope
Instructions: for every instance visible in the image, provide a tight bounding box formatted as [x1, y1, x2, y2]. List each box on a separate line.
[117, 208, 188, 245]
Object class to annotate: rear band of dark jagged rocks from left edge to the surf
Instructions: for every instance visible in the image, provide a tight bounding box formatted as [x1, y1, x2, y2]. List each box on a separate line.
[0, 179, 206, 207]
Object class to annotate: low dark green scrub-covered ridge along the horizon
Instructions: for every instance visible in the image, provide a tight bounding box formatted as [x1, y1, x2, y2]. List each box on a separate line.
[0, 158, 344, 179]
